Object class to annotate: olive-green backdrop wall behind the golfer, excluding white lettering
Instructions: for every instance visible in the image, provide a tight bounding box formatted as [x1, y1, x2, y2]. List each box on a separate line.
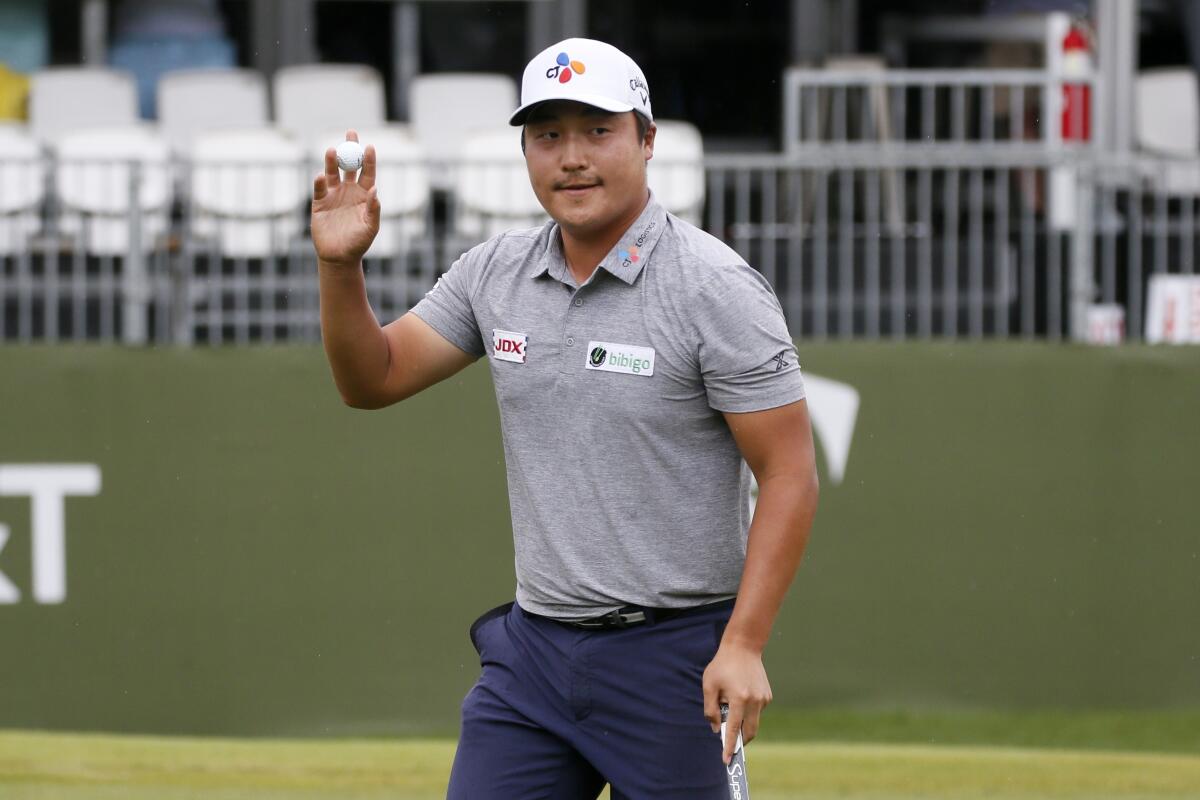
[0, 343, 1200, 735]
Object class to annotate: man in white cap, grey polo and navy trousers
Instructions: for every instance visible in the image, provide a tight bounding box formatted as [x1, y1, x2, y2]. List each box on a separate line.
[312, 38, 817, 800]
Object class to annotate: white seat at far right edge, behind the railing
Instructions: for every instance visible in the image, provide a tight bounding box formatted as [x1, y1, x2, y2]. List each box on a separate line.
[1134, 68, 1200, 196]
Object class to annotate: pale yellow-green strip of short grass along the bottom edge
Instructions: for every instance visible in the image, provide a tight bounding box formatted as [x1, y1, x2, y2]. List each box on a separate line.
[0, 732, 1200, 800]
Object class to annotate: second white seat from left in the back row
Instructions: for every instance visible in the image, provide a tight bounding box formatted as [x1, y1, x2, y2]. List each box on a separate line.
[157, 68, 270, 155]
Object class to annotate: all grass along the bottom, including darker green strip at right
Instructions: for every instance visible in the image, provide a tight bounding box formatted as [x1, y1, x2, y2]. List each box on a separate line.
[7, 709, 1200, 800]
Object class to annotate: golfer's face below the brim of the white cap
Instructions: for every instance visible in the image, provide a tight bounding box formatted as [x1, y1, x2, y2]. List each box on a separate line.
[524, 101, 654, 236]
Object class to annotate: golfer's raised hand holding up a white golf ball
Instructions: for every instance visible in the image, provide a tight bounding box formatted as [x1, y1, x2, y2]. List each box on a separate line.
[312, 131, 380, 269]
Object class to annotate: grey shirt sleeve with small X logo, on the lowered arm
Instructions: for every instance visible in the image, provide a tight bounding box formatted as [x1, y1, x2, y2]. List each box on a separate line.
[695, 264, 804, 413]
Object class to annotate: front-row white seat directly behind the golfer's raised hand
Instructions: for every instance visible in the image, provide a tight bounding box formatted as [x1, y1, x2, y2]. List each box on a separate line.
[313, 125, 430, 258]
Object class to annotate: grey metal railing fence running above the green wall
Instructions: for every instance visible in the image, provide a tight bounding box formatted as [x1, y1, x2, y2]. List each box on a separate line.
[0, 71, 1200, 344]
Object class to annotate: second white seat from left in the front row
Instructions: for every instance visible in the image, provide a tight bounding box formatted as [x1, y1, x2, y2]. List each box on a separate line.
[54, 125, 170, 255]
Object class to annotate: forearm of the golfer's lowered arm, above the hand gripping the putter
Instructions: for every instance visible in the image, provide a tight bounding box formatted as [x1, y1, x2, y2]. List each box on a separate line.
[722, 473, 817, 652]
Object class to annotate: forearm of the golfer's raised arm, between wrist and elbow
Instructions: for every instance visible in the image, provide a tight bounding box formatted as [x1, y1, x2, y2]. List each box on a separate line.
[317, 261, 390, 407]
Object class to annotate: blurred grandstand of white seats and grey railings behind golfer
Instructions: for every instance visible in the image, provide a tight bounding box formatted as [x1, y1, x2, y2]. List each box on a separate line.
[0, 0, 1200, 343]
